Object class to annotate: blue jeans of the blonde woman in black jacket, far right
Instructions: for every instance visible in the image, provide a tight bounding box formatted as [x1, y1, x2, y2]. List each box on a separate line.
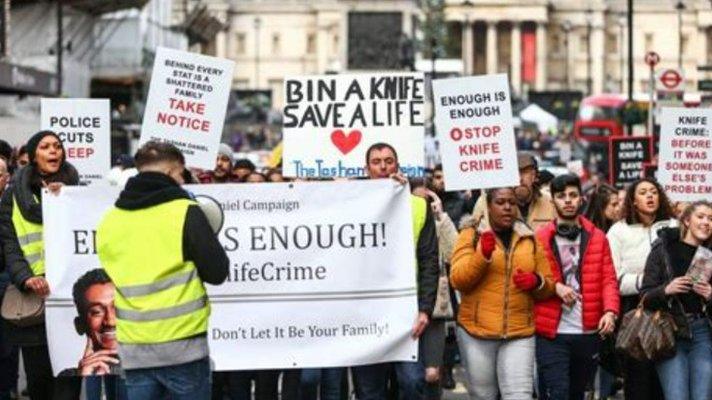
[655, 318, 712, 400]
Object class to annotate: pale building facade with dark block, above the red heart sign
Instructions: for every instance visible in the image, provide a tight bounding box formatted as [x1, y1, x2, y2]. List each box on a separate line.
[225, 0, 419, 108]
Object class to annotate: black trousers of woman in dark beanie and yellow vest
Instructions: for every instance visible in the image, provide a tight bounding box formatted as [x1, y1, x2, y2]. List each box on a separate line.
[21, 345, 82, 400]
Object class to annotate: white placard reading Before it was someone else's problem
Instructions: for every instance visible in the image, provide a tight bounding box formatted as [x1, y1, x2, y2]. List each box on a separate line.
[657, 108, 712, 202]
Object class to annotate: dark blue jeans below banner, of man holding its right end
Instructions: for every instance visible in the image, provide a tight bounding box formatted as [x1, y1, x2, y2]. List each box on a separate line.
[351, 361, 425, 400]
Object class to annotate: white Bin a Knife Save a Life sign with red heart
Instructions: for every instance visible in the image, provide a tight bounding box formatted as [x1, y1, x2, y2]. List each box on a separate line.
[282, 73, 425, 177]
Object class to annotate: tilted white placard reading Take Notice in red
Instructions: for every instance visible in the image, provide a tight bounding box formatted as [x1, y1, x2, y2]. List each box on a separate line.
[140, 47, 235, 169]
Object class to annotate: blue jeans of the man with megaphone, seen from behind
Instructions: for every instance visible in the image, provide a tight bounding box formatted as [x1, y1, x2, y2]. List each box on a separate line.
[125, 357, 211, 400]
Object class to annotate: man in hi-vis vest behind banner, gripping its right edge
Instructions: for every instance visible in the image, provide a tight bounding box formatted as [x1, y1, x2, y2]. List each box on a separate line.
[351, 143, 439, 400]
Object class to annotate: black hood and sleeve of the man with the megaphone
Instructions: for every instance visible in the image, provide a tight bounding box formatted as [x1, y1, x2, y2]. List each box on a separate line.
[115, 172, 230, 285]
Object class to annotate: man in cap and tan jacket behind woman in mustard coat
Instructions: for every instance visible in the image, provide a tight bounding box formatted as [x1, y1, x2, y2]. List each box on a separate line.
[472, 152, 556, 230]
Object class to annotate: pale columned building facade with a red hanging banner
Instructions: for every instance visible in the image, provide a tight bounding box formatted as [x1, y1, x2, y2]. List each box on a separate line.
[445, 0, 712, 94]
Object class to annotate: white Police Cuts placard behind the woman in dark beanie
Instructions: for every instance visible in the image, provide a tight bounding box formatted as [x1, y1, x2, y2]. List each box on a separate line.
[40, 99, 111, 185]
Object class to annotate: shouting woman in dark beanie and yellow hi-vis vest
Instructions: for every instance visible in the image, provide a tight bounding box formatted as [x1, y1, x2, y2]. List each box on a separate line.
[0, 131, 81, 400]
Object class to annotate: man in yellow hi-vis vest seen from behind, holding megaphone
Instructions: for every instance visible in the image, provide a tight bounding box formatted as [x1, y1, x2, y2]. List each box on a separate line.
[97, 142, 229, 400]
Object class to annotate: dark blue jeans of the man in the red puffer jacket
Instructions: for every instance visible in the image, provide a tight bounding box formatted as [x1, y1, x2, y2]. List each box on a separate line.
[536, 333, 601, 400]
